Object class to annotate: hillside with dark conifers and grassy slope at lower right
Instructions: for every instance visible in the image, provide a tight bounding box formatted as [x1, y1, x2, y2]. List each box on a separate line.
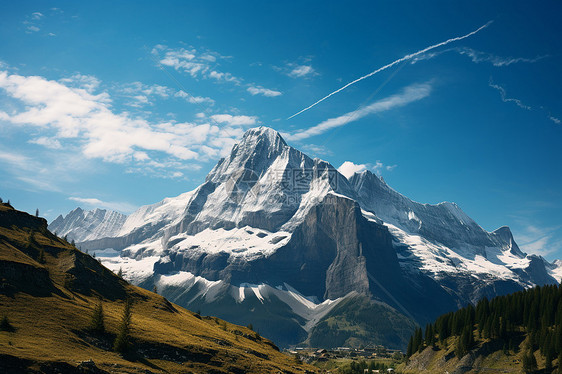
[400, 286, 562, 373]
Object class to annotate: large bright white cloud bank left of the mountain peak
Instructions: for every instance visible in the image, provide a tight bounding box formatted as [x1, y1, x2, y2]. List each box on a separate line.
[0, 71, 252, 167]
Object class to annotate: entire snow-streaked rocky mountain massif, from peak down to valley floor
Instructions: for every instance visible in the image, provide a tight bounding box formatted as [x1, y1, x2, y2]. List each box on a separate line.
[49, 127, 562, 348]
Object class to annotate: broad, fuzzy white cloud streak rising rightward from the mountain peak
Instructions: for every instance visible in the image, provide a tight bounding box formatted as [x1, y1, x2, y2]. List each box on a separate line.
[283, 83, 431, 140]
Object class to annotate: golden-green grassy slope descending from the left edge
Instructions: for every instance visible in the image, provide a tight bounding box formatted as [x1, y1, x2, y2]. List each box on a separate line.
[0, 204, 315, 373]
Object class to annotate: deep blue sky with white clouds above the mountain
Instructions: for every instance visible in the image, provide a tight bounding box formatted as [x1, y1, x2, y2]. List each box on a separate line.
[0, 1, 562, 259]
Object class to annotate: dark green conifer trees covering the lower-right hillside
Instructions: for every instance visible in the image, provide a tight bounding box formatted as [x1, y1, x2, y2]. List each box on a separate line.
[407, 285, 562, 373]
